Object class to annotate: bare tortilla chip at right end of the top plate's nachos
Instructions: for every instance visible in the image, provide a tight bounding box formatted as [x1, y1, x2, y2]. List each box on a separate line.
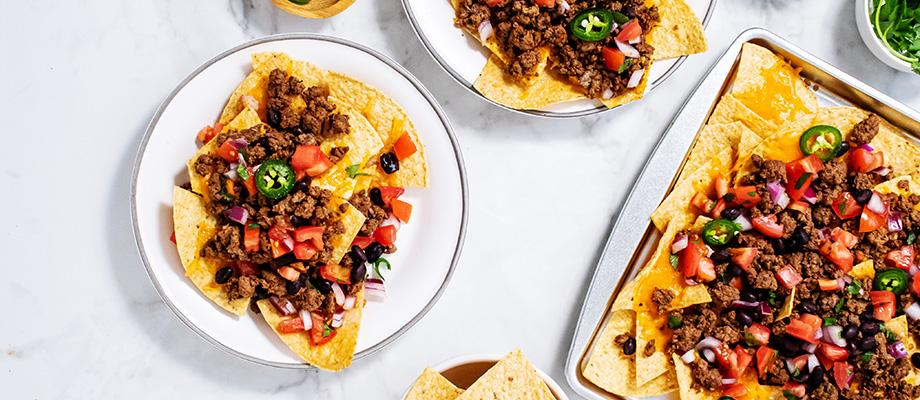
[646, 0, 708, 60]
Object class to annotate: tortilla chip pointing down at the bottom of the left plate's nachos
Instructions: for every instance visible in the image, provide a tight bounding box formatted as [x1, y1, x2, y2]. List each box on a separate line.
[256, 290, 364, 371]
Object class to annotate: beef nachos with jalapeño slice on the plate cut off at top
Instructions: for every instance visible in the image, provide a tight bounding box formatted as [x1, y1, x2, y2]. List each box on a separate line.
[451, 0, 707, 109]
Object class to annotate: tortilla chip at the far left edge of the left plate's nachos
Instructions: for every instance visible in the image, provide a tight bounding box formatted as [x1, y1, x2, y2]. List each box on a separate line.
[173, 186, 249, 315]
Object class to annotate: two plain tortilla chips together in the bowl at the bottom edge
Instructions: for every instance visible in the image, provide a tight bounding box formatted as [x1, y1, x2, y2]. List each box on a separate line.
[406, 349, 556, 400]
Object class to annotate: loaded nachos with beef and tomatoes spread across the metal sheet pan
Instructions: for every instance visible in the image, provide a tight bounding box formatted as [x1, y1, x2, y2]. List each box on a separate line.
[582, 43, 920, 400]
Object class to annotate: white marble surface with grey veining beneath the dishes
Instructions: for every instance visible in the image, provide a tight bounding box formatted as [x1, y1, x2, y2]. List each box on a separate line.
[0, 0, 920, 399]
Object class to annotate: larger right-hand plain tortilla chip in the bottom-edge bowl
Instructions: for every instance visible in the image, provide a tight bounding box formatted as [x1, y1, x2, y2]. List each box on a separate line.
[457, 349, 556, 400]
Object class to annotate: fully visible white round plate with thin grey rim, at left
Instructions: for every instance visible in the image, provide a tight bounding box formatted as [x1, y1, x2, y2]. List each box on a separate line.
[131, 34, 468, 368]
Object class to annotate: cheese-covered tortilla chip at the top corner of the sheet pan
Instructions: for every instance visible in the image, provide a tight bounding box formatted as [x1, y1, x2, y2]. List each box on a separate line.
[731, 43, 818, 125]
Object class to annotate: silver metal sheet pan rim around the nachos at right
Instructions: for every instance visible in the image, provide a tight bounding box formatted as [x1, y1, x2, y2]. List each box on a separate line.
[565, 28, 920, 400]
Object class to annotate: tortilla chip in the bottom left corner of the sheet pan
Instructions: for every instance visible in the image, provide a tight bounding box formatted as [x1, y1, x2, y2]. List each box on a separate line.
[582, 310, 677, 397]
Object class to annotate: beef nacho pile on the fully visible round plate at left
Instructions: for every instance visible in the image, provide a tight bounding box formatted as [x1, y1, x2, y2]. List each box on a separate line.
[173, 53, 428, 371]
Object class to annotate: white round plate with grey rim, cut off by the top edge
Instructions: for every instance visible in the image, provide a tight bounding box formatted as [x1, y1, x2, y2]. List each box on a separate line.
[402, 0, 716, 118]
